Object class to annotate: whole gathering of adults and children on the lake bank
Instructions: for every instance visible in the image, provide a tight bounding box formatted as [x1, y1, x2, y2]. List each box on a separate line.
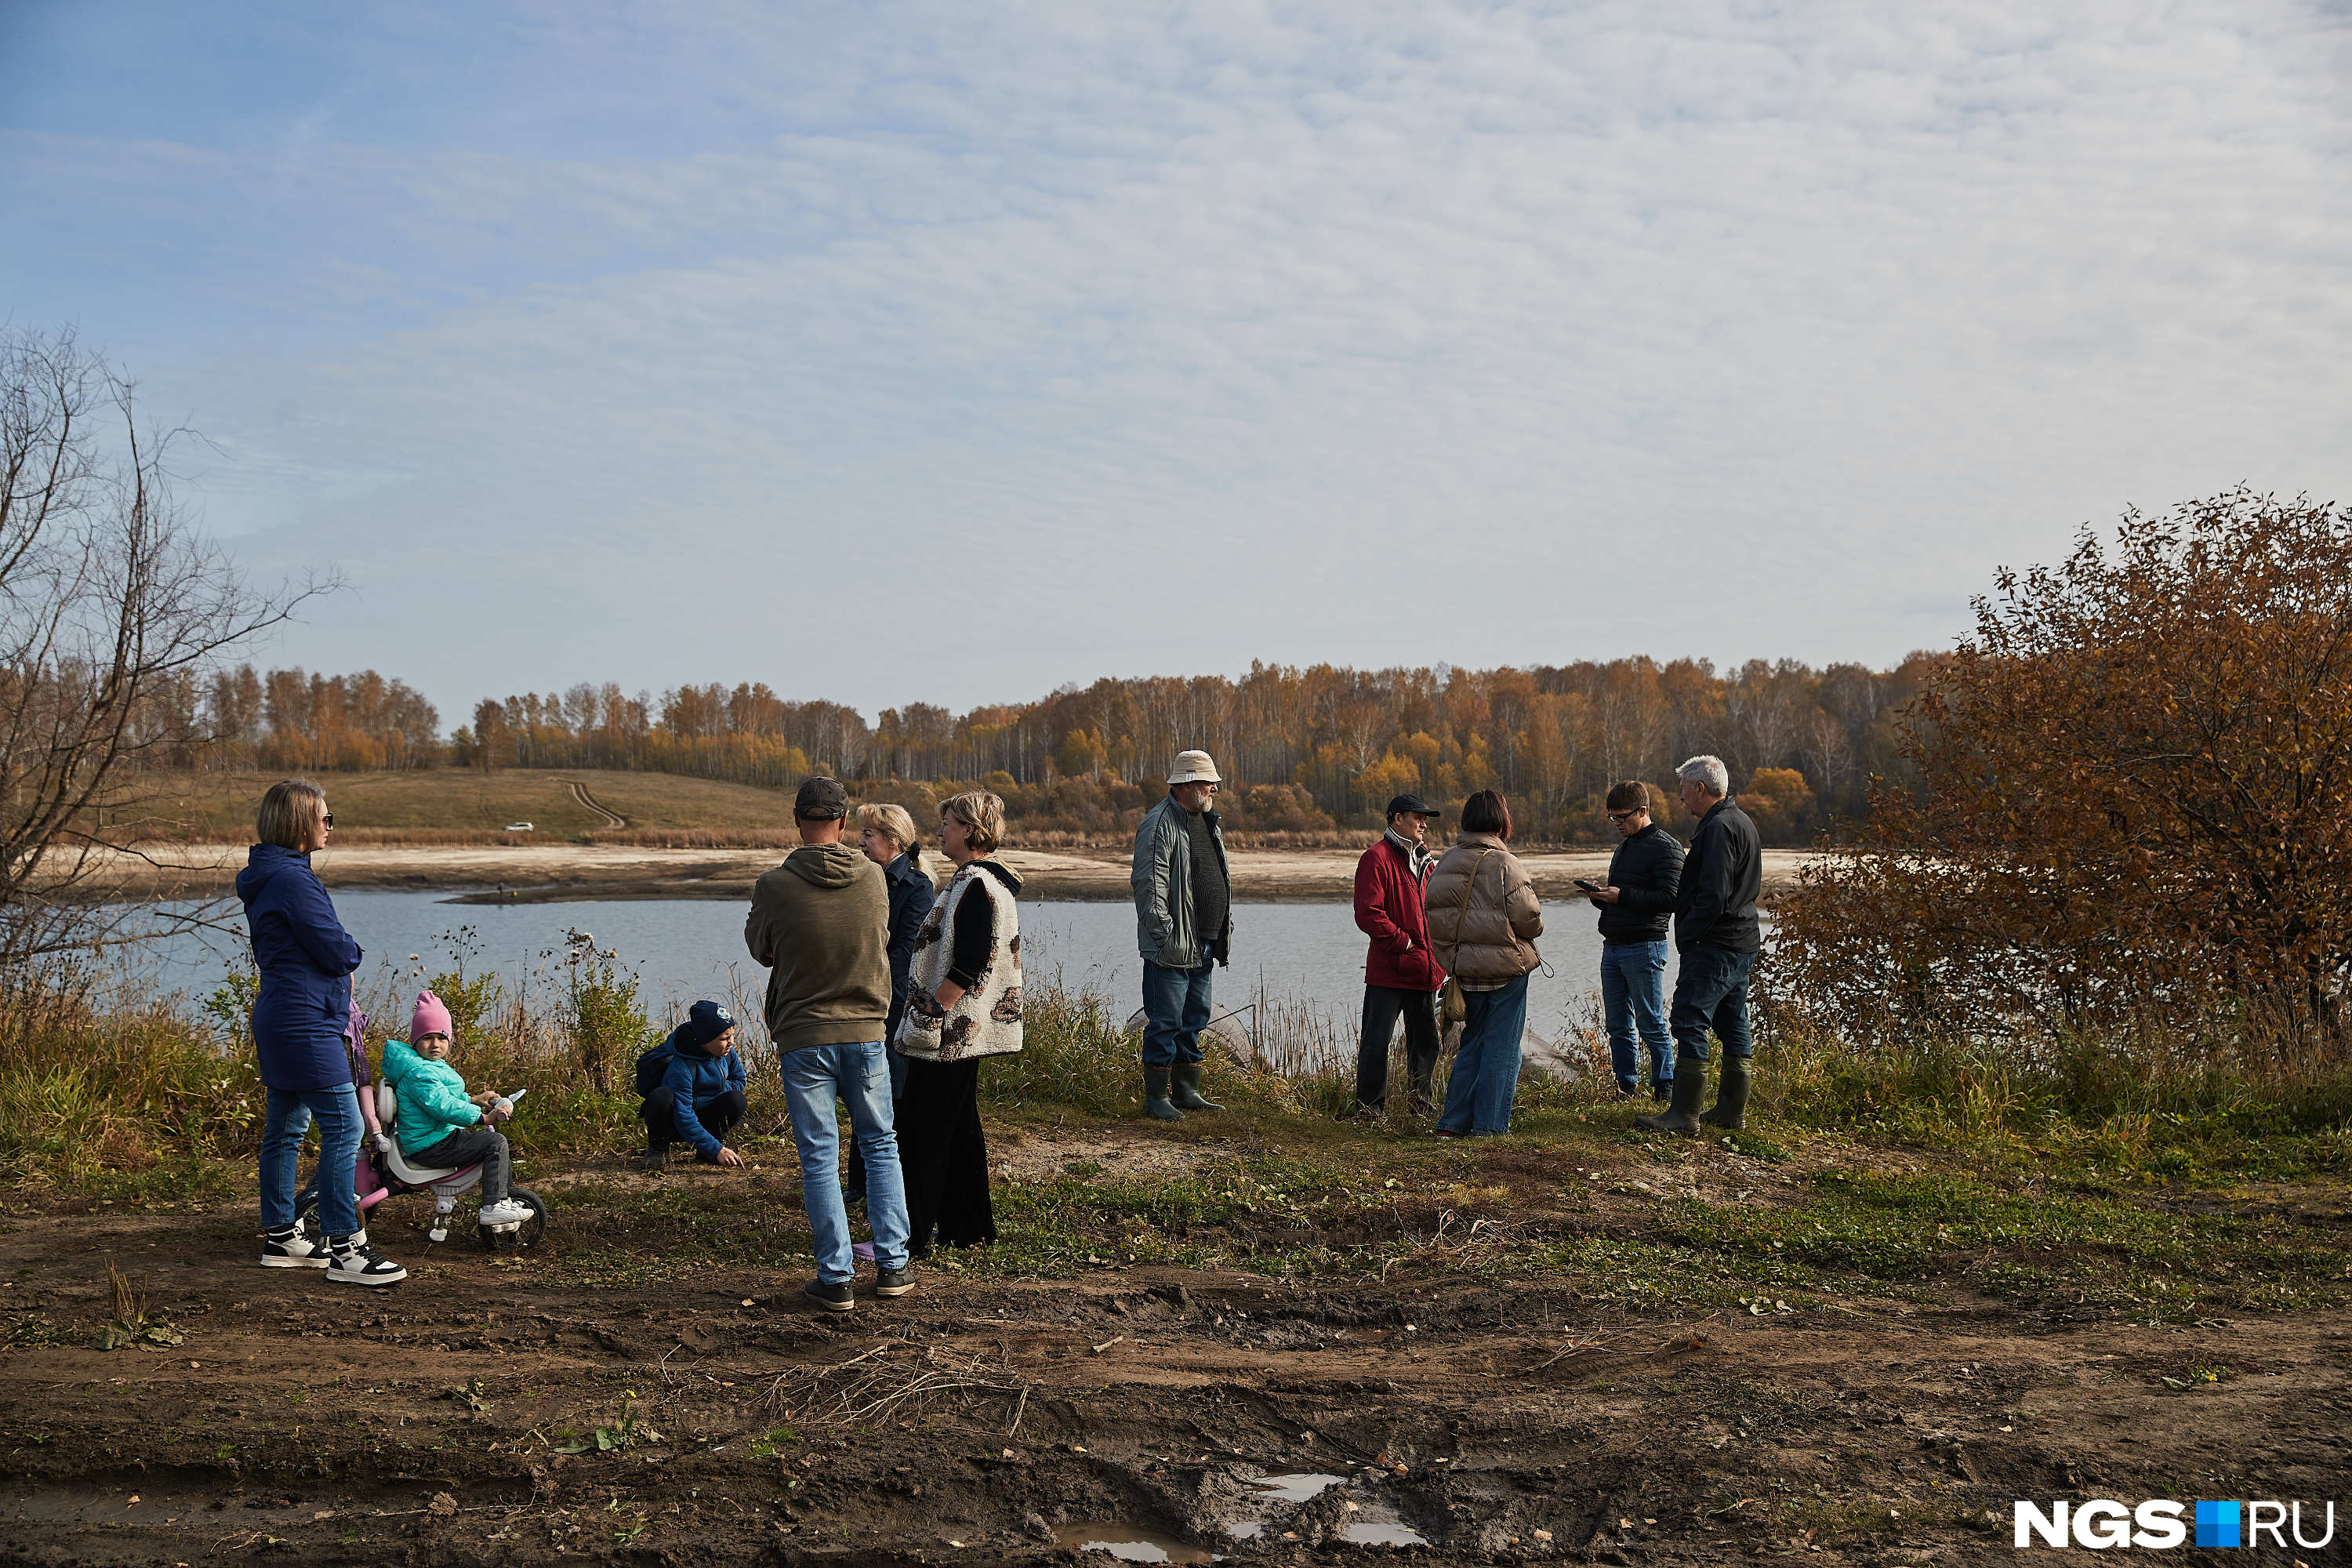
[238, 750, 1762, 1312]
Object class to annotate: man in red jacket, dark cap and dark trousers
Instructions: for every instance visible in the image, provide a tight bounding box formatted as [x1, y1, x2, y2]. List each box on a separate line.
[1355, 794, 1446, 1119]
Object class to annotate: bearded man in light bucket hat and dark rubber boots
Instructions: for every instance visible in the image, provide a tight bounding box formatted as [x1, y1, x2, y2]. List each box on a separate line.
[1131, 753, 1232, 1121]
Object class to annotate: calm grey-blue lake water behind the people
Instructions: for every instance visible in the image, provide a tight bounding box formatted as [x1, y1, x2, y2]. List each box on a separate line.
[114, 891, 1672, 1039]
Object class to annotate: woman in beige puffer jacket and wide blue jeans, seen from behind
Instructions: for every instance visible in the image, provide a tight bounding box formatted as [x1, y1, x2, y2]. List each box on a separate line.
[1425, 789, 1543, 1138]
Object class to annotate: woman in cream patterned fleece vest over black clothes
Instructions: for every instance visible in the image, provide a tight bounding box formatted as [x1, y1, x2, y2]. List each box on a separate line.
[891, 789, 1021, 1258]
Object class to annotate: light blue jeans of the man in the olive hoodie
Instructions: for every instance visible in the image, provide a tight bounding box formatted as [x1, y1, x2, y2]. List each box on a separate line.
[779, 1039, 906, 1286]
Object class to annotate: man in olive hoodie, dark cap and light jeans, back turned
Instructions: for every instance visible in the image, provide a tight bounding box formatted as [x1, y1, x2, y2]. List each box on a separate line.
[743, 779, 915, 1312]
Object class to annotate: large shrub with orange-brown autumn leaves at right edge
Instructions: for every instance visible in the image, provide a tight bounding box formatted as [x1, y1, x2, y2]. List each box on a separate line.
[1773, 489, 2352, 1062]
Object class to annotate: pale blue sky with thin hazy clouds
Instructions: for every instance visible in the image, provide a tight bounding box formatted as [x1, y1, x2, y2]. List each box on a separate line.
[0, 0, 2352, 724]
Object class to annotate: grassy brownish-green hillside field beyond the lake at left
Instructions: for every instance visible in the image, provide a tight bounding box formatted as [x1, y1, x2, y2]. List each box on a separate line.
[124, 769, 793, 844]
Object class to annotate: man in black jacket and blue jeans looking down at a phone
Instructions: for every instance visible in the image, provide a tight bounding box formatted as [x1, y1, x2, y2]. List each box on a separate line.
[1576, 779, 1682, 1100]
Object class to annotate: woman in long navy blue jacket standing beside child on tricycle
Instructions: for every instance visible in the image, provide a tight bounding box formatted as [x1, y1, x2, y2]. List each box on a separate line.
[238, 779, 409, 1286]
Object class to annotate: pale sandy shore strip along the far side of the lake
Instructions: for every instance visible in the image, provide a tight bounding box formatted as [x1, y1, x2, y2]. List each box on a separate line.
[78, 844, 1816, 902]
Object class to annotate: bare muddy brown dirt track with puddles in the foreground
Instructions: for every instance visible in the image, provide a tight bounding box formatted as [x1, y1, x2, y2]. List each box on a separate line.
[0, 1138, 2352, 1566]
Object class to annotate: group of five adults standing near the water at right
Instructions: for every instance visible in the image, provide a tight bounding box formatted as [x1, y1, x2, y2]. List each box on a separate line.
[1131, 753, 1764, 1138]
